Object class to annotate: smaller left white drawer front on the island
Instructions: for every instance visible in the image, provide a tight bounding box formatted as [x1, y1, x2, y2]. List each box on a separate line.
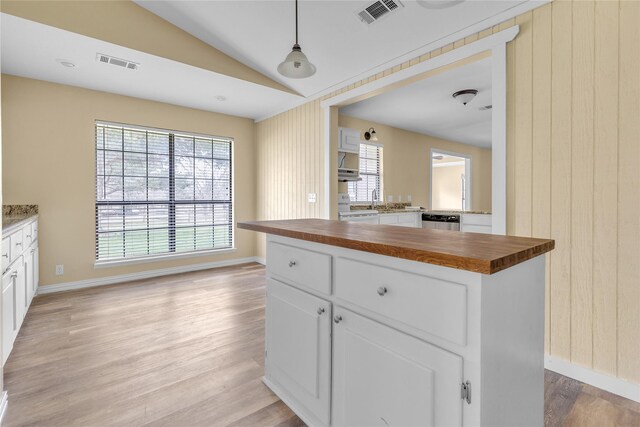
[267, 242, 331, 294]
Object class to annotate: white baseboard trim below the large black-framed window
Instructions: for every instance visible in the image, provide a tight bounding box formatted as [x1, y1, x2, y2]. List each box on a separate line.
[38, 257, 260, 295]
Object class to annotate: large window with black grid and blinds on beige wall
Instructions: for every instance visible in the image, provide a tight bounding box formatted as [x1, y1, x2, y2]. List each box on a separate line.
[96, 122, 233, 261]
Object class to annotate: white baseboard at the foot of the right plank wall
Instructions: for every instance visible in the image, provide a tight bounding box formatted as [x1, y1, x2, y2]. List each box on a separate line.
[544, 356, 640, 402]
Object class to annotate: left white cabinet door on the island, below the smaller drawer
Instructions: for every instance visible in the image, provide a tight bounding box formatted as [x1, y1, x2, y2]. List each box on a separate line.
[265, 279, 331, 425]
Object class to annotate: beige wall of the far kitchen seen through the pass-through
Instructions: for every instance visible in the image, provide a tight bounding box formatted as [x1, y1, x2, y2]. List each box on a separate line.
[336, 115, 491, 211]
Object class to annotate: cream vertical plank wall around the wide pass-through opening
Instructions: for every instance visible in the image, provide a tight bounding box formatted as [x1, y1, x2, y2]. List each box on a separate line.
[256, 0, 640, 383]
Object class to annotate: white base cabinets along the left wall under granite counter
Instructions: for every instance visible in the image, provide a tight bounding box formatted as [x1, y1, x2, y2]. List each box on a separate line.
[2, 220, 39, 364]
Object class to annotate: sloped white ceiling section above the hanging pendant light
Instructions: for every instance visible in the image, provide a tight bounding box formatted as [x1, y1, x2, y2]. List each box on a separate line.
[136, 0, 544, 97]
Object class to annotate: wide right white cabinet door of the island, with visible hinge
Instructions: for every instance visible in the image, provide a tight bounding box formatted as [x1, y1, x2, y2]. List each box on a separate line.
[332, 307, 463, 426]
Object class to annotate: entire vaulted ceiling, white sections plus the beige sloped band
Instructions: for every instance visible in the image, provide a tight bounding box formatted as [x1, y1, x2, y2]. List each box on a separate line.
[0, 0, 546, 119]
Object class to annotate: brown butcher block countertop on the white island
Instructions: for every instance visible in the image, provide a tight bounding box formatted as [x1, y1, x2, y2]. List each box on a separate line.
[238, 219, 555, 274]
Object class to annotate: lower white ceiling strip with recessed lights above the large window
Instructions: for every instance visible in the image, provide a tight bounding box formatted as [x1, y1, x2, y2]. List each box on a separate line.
[0, 13, 301, 119]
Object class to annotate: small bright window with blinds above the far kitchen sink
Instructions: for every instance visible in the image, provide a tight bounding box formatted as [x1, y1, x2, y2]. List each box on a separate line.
[347, 143, 382, 203]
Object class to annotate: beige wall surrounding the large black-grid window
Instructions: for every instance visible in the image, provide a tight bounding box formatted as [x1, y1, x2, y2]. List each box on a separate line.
[2, 75, 256, 286]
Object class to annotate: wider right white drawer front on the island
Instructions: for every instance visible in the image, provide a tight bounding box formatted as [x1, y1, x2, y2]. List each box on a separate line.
[335, 258, 467, 345]
